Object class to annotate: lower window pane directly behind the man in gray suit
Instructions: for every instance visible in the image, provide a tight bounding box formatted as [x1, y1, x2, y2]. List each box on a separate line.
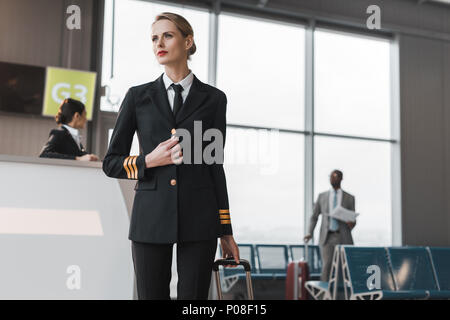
[308, 137, 392, 246]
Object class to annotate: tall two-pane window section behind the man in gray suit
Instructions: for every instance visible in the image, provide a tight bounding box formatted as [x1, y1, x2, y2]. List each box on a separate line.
[314, 29, 392, 245]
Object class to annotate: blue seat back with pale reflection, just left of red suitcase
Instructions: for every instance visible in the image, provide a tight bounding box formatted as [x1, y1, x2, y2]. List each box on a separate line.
[255, 244, 289, 279]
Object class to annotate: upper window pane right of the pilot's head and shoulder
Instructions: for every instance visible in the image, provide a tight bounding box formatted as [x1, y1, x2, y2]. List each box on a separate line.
[217, 14, 305, 130]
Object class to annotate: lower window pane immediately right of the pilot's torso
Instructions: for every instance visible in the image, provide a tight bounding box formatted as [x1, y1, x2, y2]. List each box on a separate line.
[224, 127, 304, 244]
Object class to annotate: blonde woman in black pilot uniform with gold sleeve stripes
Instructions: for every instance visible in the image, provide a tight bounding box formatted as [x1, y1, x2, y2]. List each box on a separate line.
[103, 12, 239, 299]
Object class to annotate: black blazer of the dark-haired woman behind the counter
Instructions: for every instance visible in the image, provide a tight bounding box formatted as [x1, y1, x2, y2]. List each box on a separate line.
[39, 126, 87, 160]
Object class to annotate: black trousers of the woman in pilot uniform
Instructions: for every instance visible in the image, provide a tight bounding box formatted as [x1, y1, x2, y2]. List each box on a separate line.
[131, 239, 217, 300]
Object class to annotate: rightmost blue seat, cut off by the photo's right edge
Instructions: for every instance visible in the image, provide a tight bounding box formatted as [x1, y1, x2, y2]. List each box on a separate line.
[427, 247, 450, 299]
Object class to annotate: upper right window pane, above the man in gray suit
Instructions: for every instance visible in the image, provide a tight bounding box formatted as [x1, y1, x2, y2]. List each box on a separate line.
[314, 30, 391, 139]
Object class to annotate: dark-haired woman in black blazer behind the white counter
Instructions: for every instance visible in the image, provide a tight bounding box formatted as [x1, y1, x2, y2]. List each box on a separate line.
[39, 98, 98, 161]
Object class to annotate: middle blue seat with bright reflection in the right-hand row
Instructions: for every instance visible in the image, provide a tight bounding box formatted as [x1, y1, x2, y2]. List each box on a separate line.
[387, 247, 439, 299]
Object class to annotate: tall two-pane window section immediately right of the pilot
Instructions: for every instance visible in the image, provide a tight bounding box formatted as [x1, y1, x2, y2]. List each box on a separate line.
[217, 14, 305, 243]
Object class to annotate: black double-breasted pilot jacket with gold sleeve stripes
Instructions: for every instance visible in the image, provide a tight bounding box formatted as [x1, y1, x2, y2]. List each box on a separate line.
[103, 74, 232, 243]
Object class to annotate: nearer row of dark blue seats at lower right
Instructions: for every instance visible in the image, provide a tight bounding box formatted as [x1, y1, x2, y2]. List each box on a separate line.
[306, 245, 450, 300]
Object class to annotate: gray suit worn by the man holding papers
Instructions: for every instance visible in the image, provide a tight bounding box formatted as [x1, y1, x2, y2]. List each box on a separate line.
[309, 190, 355, 281]
